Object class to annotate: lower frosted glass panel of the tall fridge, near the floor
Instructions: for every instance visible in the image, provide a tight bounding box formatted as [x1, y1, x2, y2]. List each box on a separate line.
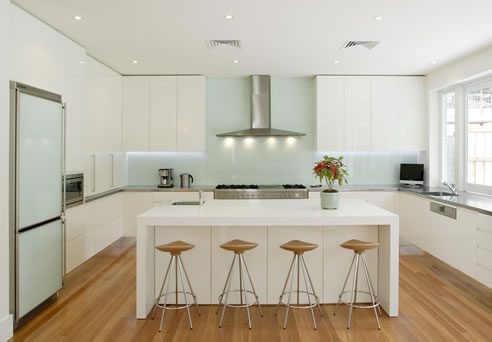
[17, 220, 63, 318]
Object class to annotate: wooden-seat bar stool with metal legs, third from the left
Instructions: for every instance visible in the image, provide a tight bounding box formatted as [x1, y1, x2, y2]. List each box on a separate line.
[275, 240, 323, 330]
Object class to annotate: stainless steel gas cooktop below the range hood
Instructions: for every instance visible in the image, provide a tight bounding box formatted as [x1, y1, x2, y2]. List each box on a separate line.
[214, 184, 308, 199]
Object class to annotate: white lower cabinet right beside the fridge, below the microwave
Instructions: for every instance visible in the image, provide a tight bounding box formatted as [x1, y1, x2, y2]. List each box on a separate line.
[65, 193, 124, 272]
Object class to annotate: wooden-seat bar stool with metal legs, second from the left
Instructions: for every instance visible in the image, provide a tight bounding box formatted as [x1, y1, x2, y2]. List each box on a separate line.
[216, 240, 263, 329]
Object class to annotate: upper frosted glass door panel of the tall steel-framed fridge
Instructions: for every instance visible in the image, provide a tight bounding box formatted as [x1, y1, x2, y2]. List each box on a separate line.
[17, 92, 63, 229]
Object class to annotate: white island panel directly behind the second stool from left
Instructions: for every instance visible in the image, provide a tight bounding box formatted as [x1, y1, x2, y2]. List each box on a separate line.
[210, 227, 268, 304]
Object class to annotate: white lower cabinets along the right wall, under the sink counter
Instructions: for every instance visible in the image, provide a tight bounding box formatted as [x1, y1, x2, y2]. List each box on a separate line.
[398, 193, 492, 287]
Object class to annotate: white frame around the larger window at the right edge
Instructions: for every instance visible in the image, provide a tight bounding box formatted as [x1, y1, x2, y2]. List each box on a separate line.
[463, 77, 492, 195]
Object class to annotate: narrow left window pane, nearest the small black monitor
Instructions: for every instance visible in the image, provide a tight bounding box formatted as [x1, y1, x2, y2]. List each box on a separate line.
[441, 91, 456, 183]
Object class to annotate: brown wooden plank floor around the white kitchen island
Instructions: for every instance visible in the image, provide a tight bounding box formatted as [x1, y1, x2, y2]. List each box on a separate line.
[12, 238, 492, 342]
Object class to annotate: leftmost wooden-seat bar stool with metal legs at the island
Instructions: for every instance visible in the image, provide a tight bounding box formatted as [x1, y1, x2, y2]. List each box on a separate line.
[152, 241, 200, 332]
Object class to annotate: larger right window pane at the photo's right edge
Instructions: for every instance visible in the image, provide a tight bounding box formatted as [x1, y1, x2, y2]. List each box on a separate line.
[465, 81, 492, 193]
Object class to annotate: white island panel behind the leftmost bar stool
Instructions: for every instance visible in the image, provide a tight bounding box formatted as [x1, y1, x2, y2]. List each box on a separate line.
[154, 227, 211, 304]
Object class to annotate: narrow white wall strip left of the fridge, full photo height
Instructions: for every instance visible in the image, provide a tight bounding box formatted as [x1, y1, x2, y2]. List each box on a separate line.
[0, 0, 12, 341]
